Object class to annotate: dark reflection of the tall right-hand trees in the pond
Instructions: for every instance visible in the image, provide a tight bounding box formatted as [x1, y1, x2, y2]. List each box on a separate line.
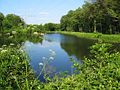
[61, 36, 95, 59]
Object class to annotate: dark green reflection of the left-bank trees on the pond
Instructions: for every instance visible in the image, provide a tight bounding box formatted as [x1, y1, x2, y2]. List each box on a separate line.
[0, 34, 43, 47]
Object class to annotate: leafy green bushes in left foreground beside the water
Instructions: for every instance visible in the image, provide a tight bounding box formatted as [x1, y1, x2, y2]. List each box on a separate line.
[0, 45, 40, 90]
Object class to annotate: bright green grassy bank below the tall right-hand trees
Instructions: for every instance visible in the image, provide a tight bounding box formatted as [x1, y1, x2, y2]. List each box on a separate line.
[57, 31, 120, 43]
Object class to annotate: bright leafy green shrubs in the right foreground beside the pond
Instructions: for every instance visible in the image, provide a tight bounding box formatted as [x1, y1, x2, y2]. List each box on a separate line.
[41, 43, 120, 90]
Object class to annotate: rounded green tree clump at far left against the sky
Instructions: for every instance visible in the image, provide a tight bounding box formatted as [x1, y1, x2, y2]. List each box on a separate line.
[0, 13, 25, 34]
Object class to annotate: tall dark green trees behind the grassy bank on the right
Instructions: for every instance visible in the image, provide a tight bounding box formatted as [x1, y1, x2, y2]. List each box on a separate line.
[60, 0, 120, 34]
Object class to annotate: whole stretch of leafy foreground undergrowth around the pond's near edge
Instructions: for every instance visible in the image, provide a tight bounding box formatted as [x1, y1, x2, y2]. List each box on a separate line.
[0, 43, 120, 90]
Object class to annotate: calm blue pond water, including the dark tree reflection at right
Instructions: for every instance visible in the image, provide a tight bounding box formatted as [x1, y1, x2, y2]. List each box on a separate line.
[22, 34, 95, 81]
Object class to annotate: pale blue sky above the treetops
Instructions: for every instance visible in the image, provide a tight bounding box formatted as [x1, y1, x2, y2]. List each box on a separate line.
[0, 0, 84, 24]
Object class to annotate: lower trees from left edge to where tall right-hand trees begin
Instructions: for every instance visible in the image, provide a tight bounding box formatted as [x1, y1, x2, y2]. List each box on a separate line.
[0, 12, 60, 32]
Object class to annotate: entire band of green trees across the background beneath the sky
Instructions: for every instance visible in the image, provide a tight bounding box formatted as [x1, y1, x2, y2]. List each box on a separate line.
[0, 0, 120, 34]
